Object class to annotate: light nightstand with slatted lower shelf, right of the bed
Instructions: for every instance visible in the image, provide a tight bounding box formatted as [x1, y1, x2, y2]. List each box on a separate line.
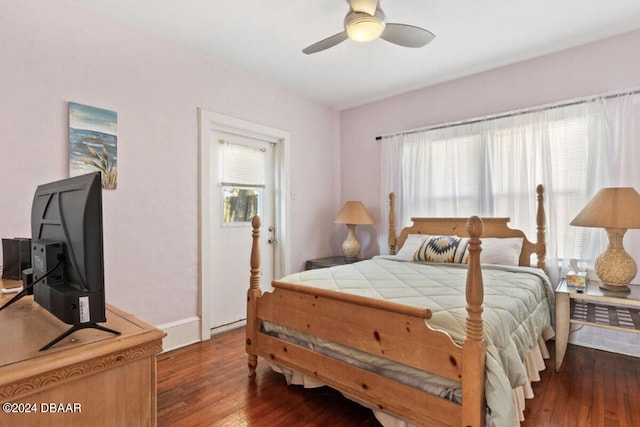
[556, 279, 640, 372]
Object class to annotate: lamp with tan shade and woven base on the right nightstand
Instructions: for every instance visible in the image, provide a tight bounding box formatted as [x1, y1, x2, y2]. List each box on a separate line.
[571, 187, 640, 292]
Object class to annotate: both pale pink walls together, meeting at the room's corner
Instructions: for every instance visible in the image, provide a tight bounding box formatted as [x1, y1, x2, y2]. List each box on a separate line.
[0, 0, 640, 342]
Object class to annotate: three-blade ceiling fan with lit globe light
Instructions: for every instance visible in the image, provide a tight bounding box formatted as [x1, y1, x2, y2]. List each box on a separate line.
[302, 0, 435, 55]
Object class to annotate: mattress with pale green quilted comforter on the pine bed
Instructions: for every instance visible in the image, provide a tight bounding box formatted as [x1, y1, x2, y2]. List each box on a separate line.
[263, 257, 554, 427]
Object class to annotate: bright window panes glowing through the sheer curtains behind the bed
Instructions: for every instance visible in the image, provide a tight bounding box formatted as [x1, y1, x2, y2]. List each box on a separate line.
[402, 113, 587, 246]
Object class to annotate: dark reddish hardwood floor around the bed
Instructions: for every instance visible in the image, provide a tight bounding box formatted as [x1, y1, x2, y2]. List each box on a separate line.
[158, 329, 640, 427]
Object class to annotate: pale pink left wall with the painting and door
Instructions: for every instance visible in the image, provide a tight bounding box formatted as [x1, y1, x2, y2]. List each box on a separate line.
[0, 0, 340, 325]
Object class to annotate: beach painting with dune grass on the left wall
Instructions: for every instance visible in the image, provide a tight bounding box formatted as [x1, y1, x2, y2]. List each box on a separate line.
[69, 102, 118, 190]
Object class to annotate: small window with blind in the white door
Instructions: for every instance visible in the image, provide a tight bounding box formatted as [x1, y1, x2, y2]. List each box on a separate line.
[221, 141, 265, 227]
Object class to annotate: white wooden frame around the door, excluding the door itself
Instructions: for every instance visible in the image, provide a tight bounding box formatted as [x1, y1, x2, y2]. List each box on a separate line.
[198, 108, 291, 341]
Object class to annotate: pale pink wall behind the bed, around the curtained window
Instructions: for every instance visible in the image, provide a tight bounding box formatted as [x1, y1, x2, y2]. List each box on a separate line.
[340, 31, 640, 255]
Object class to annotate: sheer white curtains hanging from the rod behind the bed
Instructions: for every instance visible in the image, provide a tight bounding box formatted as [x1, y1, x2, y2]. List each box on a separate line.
[380, 93, 640, 279]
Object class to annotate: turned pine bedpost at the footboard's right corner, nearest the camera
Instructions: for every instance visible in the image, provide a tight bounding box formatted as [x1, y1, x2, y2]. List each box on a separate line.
[462, 216, 486, 426]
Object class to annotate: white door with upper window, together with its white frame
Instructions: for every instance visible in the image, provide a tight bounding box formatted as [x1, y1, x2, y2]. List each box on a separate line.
[199, 110, 289, 340]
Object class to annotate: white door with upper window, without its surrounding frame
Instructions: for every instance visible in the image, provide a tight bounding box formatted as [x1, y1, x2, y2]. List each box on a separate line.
[208, 130, 277, 329]
